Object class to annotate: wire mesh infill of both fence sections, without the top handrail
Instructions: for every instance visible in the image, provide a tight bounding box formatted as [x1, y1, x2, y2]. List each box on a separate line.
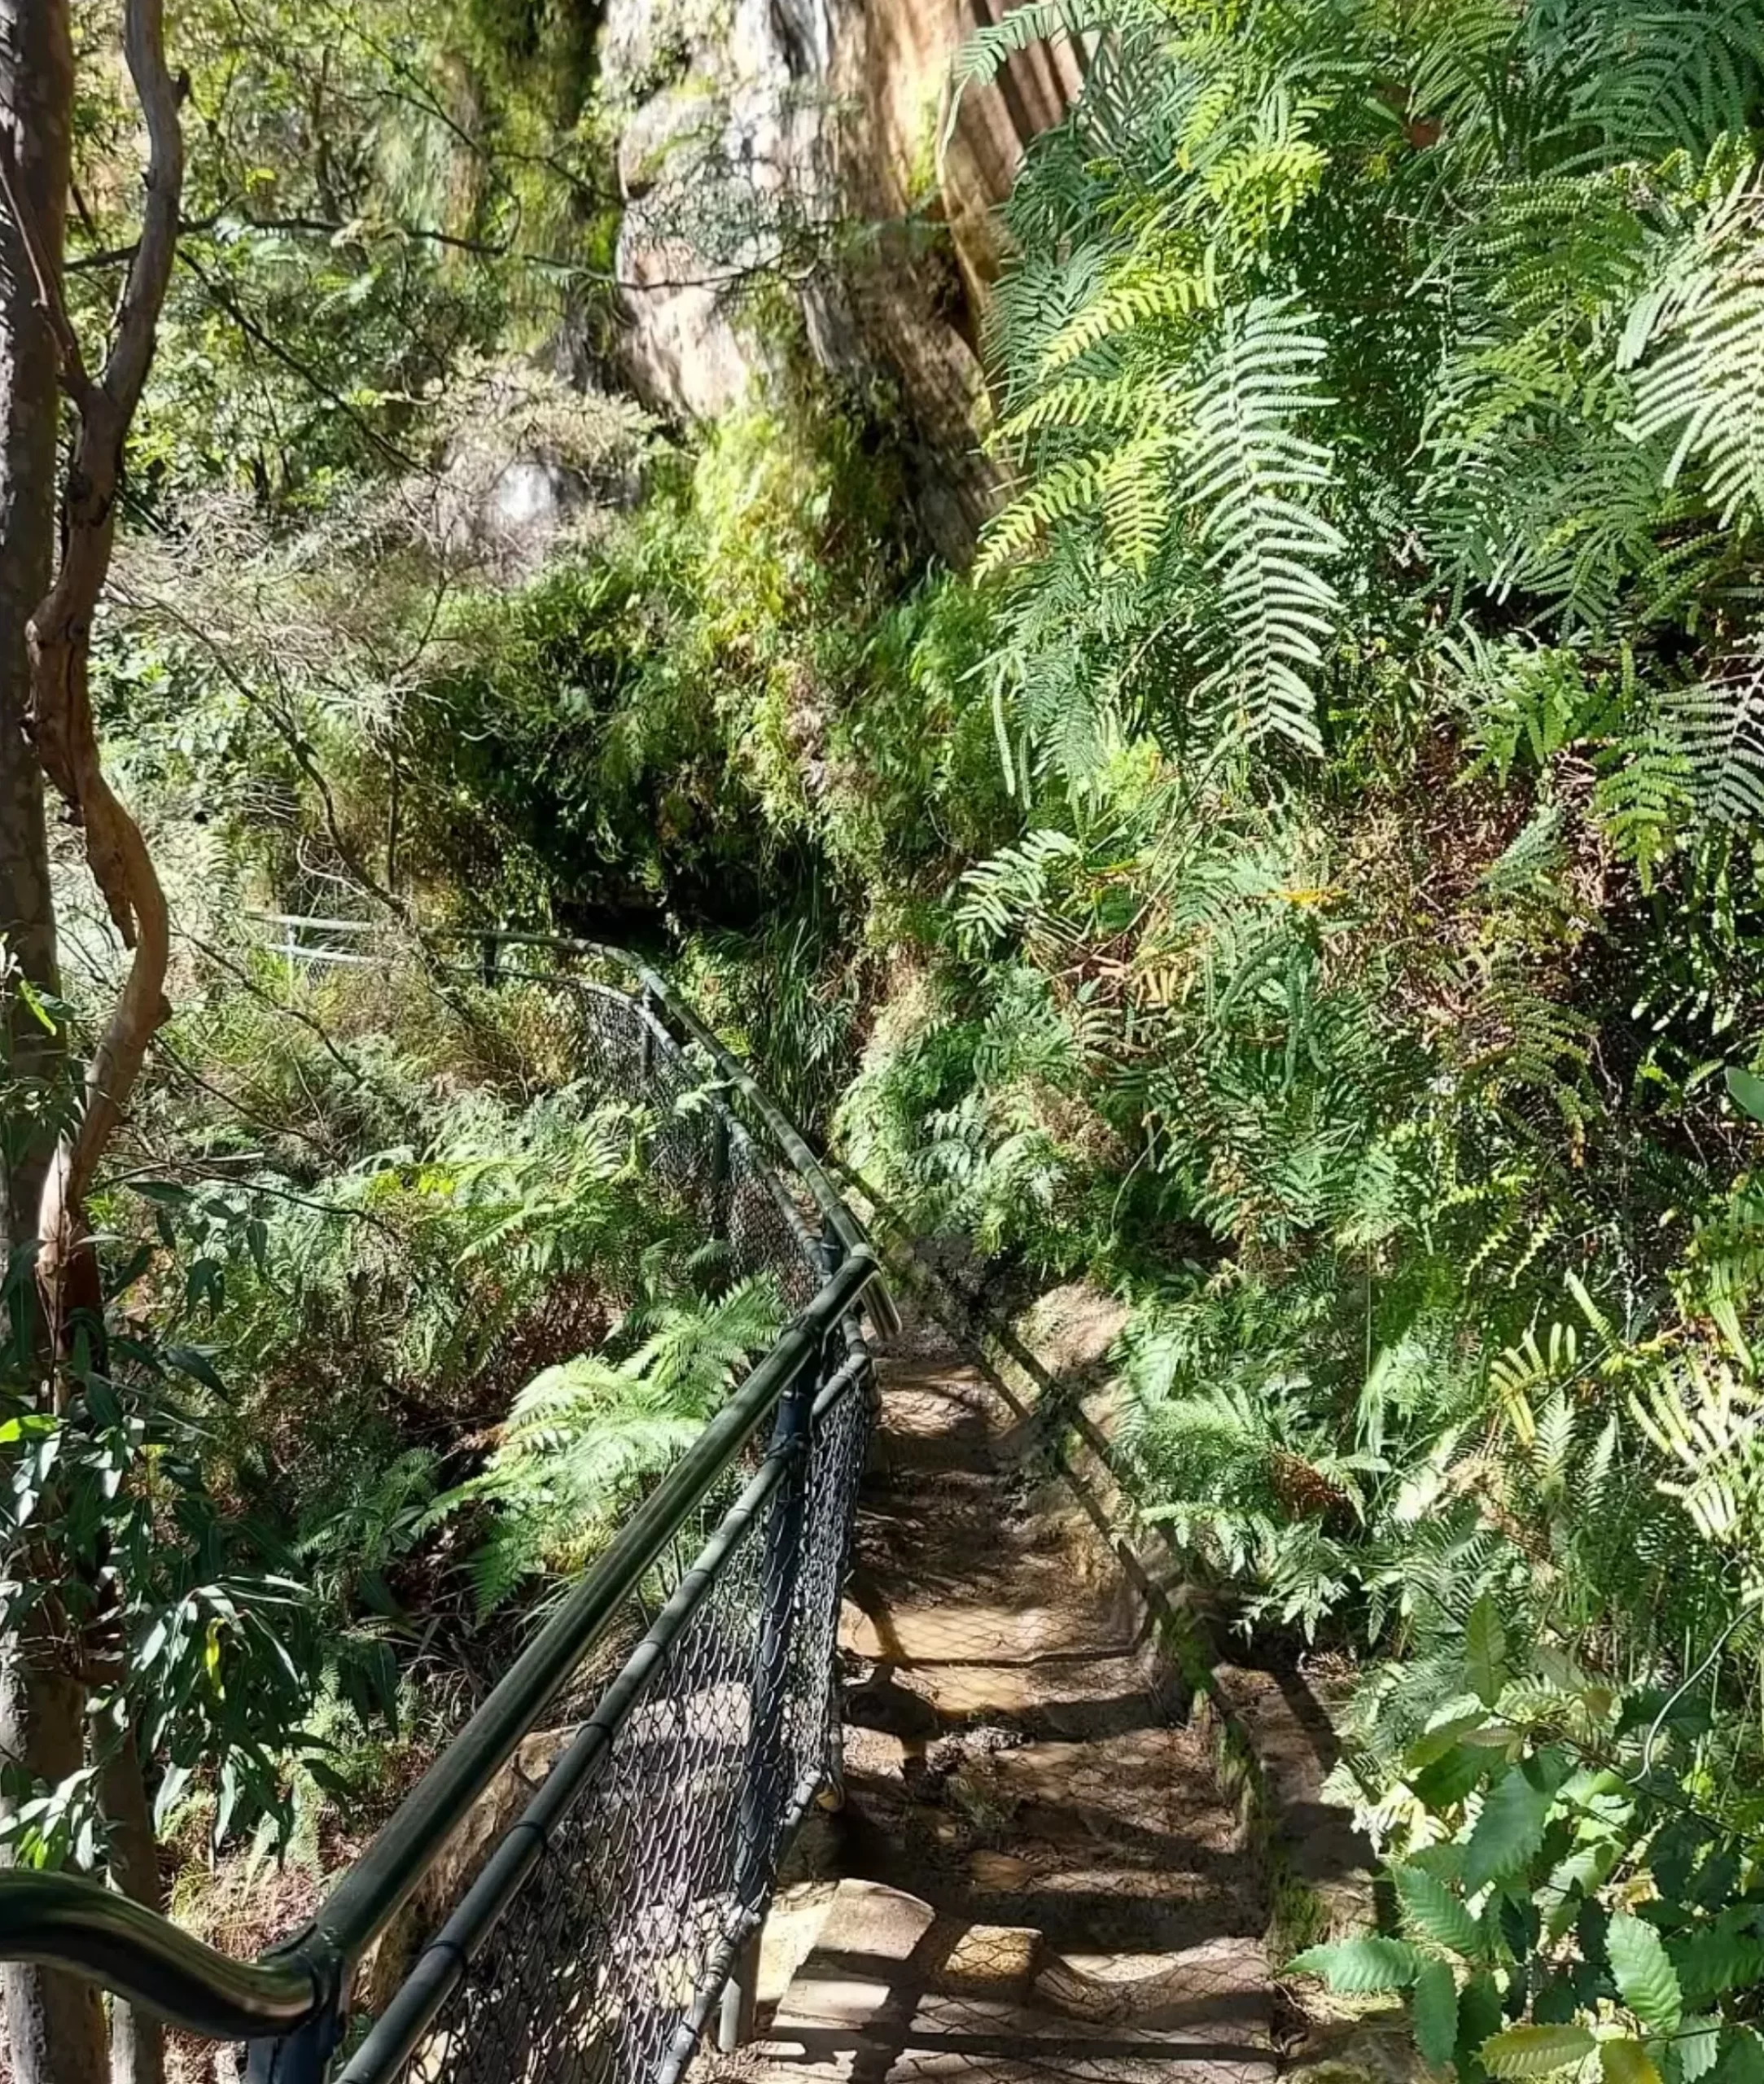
[323, 979, 873, 2084]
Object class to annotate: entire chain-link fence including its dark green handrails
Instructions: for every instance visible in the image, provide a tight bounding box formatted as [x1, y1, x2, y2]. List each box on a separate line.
[0, 933, 884, 2084]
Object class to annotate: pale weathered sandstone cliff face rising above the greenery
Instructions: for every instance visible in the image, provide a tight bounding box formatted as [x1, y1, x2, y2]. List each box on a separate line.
[602, 0, 1080, 565]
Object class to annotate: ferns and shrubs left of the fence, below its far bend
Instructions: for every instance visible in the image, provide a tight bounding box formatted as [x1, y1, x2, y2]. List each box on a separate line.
[8, 940, 780, 1917]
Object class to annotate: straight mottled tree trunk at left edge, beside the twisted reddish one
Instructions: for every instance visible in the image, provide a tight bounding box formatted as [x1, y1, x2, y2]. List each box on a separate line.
[0, 0, 107, 2084]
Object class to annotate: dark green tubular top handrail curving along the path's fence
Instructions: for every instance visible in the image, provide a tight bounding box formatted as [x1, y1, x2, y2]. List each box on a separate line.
[0, 954, 899, 2077]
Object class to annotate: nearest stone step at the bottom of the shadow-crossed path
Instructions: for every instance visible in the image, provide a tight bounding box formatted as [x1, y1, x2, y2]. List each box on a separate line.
[753, 1880, 1274, 2084]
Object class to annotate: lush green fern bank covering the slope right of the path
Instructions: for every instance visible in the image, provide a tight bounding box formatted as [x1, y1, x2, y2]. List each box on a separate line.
[840, 7, 1764, 2080]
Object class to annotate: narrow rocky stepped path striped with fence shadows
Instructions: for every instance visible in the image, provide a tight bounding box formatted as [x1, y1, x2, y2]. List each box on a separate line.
[759, 1357, 1272, 2084]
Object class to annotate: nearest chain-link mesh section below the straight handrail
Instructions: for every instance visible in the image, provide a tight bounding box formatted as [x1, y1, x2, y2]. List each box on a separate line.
[342, 1346, 869, 2084]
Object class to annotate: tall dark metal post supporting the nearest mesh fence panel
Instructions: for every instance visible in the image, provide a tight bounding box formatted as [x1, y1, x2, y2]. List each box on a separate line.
[717, 1367, 821, 2055]
